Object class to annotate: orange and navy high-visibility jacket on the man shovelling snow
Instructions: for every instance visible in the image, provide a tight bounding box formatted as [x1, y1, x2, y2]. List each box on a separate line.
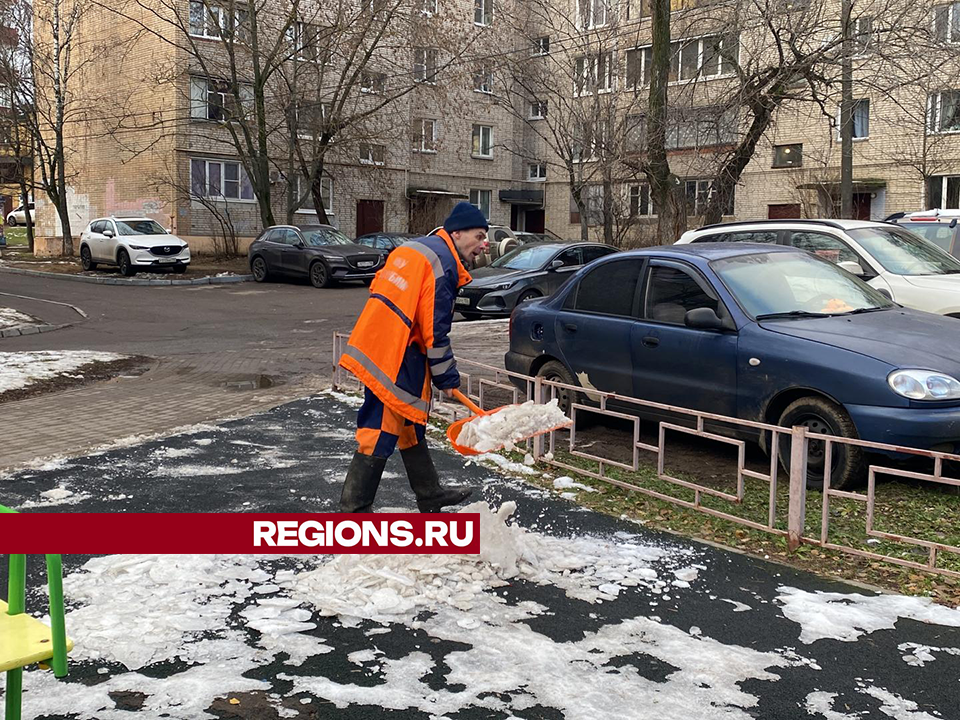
[340, 230, 471, 424]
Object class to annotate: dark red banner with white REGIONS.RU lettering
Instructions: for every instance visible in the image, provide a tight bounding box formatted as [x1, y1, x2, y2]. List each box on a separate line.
[0, 513, 480, 555]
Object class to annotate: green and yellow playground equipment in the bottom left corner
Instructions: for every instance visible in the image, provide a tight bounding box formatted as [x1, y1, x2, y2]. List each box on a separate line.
[0, 505, 73, 720]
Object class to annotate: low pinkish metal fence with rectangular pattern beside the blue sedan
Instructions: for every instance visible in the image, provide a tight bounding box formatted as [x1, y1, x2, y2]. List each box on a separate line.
[333, 333, 960, 577]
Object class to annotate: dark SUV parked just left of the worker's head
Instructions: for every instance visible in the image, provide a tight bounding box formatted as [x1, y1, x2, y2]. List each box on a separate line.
[247, 225, 388, 288]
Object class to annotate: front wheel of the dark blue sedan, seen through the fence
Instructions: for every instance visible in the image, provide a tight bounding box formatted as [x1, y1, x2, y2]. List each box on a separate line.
[778, 397, 863, 490]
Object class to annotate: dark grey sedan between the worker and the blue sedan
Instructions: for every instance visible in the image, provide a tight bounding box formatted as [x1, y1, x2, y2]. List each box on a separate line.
[455, 242, 617, 320]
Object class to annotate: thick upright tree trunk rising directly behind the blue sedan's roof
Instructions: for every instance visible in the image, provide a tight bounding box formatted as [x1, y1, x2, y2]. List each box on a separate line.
[643, 0, 687, 244]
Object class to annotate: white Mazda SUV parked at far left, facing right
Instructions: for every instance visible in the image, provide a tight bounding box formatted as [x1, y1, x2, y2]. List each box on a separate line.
[80, 217, 190, 277]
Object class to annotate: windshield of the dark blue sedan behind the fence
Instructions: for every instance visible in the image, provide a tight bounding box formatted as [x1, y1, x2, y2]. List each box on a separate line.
[711, 252, 894, 319]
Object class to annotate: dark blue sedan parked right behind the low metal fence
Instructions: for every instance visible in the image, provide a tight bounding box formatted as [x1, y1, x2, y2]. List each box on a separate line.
[505, 243, 960, 488]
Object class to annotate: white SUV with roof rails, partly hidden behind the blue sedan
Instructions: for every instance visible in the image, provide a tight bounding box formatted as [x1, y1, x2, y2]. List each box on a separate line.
[677, 220, 960, 317]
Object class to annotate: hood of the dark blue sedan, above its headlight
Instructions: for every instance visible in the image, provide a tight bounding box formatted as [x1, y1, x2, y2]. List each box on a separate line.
[760, 308, 960, 374]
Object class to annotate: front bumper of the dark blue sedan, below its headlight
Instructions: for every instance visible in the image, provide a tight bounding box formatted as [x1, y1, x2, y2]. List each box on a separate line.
[846, 405, 960, 452]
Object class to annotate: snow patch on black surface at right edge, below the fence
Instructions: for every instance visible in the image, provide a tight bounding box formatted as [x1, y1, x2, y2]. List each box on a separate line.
[777, 587, 960, 644]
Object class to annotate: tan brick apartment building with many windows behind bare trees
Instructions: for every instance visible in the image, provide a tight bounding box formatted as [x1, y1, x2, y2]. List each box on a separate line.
[28, 0, 960, 251]
